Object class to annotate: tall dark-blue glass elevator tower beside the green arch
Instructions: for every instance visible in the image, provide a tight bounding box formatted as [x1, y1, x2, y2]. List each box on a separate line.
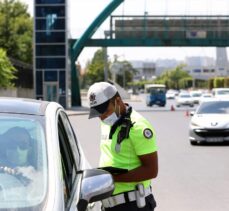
[34, 0, 69, 107]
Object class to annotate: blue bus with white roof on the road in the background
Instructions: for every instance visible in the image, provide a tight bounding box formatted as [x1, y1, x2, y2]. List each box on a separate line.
[145, 84, 166, 107]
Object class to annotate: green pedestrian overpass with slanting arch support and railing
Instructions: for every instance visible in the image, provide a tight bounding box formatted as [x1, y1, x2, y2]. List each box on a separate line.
[70, 0, 229, 106]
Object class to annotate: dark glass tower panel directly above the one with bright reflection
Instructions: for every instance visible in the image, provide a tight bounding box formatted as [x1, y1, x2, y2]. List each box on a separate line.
[36, 6, 65, 17]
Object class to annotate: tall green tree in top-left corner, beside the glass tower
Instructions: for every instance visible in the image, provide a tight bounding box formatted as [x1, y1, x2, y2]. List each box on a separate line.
[0, 0, 33, 63]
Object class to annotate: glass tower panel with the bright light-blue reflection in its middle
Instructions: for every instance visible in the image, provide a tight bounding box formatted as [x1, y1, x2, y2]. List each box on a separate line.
[36, 18, 65, 30]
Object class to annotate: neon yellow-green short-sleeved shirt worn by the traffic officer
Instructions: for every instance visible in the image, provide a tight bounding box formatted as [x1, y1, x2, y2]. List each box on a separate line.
[100, 110, 157, 195]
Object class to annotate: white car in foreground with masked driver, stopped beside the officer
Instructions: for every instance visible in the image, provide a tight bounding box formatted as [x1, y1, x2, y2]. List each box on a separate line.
[0, 98, 114, 211]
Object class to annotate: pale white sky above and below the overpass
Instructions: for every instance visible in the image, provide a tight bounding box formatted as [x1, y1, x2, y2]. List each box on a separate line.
[20, 0, 229, 66]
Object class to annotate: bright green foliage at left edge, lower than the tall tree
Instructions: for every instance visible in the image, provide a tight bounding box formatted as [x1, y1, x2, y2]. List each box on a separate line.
[0, 48, 16, 88]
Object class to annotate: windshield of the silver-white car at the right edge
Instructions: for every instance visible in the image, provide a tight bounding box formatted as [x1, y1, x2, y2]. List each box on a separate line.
[197, 101, 229, 114]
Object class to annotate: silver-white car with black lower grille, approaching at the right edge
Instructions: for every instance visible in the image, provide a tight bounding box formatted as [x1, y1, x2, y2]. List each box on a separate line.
[189, 99, 229, 145]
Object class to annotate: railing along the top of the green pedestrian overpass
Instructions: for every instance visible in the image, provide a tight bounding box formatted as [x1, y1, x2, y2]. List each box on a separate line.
[108, 15, 229, 40]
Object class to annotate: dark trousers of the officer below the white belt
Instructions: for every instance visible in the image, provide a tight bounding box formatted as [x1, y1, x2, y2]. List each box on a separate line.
[104, 194, 156, 211]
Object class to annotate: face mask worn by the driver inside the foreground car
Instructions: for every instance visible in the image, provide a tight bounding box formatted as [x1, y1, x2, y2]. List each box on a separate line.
[6, 147, 28, 166]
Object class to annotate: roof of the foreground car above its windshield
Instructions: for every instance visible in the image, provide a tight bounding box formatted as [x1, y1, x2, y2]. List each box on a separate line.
[0, 97, 49, 116]
